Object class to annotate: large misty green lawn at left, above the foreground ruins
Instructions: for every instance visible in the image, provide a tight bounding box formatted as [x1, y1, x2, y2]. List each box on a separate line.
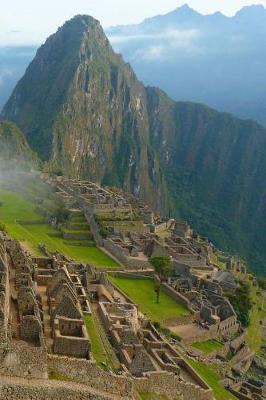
[0, 190, 118, 268]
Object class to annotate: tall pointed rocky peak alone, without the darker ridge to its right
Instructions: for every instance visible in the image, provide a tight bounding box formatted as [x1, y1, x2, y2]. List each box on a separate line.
[3, 16, 164, 211]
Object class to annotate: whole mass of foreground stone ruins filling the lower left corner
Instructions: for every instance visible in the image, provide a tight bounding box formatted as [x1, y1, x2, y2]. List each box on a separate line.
[0, 234, 216, 400]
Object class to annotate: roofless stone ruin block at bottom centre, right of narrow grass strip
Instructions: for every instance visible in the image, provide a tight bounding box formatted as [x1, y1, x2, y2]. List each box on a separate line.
[99, 302, 193, 381]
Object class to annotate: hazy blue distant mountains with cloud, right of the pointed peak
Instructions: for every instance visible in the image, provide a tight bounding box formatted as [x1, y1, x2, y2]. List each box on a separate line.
[106, 5, 266, 125]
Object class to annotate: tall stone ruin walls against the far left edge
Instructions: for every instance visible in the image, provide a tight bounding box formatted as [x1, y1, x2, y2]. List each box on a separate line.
[0, 233, 47, 378]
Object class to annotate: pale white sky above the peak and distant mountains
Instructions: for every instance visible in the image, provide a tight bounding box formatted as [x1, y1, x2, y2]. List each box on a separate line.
[0, 0, 266, 46]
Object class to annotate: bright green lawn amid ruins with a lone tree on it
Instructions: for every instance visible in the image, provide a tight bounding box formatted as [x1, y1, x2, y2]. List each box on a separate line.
[110, 276, 190, 323]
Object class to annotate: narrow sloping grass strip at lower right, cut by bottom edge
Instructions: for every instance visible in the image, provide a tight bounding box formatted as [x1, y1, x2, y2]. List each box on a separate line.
[187, 359, 236, 400]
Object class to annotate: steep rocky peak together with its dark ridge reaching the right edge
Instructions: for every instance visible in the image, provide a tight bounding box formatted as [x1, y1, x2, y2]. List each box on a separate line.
[3, 16, 266, 272]
